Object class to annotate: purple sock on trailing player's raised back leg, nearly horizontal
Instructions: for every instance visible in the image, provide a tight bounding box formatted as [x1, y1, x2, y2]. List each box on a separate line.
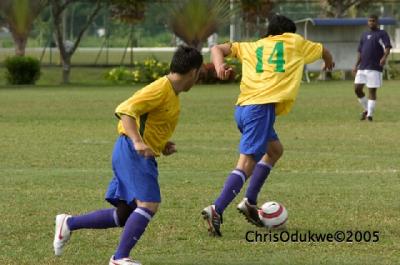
[67, 208, 118, 231]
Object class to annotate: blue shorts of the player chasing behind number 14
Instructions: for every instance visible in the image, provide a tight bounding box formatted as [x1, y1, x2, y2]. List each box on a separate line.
[105, 135, 161, 204]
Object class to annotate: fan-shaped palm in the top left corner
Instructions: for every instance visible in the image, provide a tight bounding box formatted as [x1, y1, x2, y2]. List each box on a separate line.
[0, 0, 47, 56]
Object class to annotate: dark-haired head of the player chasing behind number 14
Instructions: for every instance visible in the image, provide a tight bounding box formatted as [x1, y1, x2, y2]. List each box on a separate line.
[169, 45, 203, 91]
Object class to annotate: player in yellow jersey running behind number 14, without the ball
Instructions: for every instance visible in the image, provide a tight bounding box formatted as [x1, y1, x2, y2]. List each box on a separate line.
[54, 46, 203, 265]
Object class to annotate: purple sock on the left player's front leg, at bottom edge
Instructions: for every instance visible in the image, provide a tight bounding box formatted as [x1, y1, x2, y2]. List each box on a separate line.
[114, 207, 154, 259]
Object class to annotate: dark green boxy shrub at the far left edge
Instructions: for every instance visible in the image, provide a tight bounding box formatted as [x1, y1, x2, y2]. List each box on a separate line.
[4, 56, 40, 85]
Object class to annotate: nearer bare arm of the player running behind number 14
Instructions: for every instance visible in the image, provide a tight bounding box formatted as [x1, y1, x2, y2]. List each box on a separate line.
[121, 115, 154, 157]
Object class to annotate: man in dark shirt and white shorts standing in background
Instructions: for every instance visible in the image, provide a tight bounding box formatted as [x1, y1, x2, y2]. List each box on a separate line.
[353, 15, 392, 121]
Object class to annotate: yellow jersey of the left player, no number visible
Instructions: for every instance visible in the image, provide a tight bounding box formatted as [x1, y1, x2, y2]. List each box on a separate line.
[115, 76, 180, 156]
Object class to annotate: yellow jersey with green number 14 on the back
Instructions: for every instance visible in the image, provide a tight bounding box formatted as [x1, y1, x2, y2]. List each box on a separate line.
[231, 33, 322, 115]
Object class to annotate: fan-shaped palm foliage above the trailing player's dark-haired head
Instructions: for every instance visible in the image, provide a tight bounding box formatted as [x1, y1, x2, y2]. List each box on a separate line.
[169, 0, 230, 50]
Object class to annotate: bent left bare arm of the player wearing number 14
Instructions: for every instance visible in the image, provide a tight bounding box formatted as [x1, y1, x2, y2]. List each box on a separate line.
[211, 43, 232, 80]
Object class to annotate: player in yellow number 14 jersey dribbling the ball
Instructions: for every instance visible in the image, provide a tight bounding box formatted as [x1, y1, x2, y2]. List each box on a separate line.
[202, 15, 334, 236]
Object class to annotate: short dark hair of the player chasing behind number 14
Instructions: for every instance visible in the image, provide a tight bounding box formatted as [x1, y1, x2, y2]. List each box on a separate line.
[169, 45, 203, 74]
